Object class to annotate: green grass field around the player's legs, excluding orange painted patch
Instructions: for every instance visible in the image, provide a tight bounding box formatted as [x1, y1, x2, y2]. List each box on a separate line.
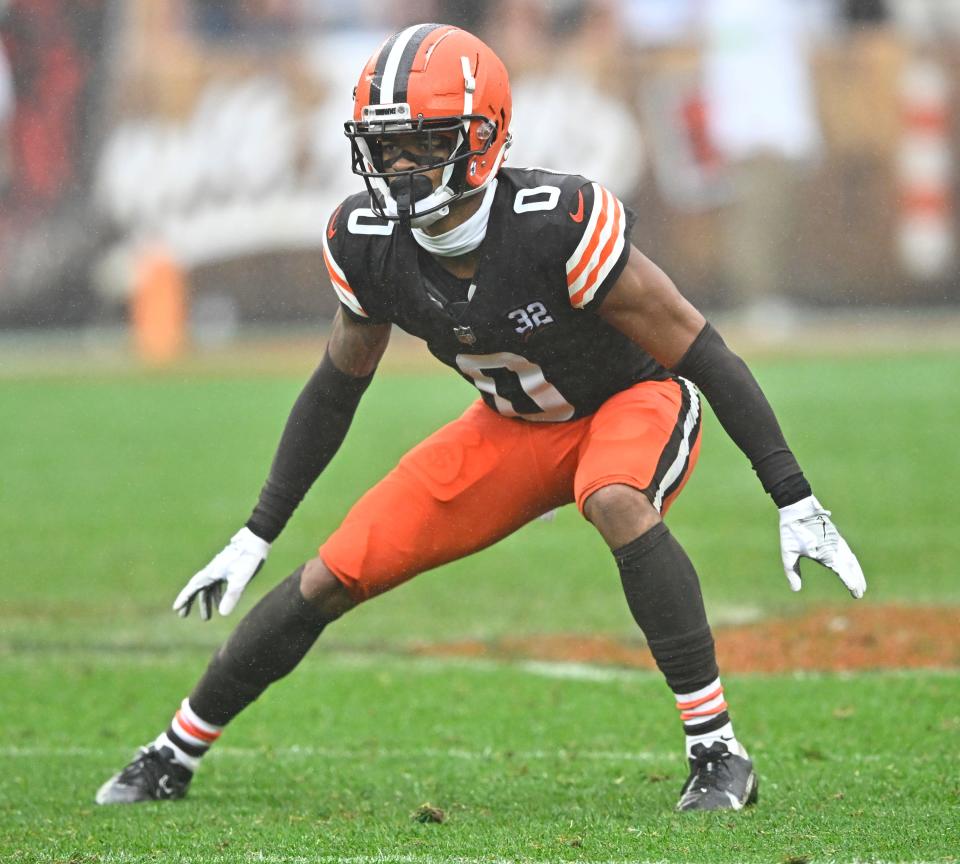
[0, 354, 960, 864]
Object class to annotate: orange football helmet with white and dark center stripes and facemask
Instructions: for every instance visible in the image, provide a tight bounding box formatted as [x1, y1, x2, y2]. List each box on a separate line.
[344, 24, 512, 227]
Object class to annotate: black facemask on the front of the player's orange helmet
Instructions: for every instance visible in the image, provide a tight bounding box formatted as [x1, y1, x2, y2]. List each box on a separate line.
[344, 103, 498, 228]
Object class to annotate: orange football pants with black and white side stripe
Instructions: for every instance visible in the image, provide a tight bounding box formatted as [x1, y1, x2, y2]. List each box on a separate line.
[319, 380, 700, 602]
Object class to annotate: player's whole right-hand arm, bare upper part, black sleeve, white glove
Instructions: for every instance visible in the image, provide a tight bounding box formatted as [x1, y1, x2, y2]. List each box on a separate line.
[600, 248, 867, 598]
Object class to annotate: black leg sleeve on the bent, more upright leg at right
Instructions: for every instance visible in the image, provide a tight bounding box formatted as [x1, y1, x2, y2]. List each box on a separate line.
[613, 522, 719, 693]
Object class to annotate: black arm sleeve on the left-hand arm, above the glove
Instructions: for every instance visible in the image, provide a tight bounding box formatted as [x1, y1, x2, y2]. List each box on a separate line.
[247, 351, 373, 543]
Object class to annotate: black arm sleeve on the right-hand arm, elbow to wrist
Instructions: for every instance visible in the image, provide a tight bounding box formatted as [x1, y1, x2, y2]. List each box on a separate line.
[673, 324, 811, 507]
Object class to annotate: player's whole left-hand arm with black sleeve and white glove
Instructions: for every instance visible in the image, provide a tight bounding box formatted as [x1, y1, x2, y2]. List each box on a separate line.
[173, 313, 390, 621]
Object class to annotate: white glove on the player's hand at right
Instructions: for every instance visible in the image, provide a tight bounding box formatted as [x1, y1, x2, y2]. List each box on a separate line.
[780, 495, 867, 599]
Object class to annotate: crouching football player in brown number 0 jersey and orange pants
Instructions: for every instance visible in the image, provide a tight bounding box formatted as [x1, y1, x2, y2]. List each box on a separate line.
[96, 24, 866, 810]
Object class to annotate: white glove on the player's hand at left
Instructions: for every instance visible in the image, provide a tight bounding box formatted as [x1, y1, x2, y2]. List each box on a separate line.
[173, 527, 270, 621]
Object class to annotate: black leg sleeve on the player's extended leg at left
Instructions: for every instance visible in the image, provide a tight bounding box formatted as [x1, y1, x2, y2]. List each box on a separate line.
[190, 567, 329, 726]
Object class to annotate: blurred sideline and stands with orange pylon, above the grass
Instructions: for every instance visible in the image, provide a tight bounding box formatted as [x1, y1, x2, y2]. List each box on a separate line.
[0, 0, 960, 363]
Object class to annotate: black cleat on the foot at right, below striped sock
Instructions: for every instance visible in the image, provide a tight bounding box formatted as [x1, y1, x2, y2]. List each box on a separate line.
[677, 741, 759, 811]
